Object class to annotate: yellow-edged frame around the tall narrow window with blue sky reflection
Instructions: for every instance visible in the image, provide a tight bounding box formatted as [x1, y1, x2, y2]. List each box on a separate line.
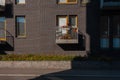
[15, 16, 26, 38]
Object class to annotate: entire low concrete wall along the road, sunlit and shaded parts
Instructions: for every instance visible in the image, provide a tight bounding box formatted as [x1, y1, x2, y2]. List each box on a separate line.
[0, 61, 120, 69]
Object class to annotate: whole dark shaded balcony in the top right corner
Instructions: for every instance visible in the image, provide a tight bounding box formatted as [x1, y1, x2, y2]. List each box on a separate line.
[100, 0, 120, 9]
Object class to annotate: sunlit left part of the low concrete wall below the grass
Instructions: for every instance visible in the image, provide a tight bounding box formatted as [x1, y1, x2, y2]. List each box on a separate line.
[0, 61, 71, 69]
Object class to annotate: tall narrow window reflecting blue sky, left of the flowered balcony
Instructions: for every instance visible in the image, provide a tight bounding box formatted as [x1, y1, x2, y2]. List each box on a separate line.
[16, 16, 26, 37]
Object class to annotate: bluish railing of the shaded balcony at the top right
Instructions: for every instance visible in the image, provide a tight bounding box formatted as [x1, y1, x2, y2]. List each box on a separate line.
[100, 0, 120, 8]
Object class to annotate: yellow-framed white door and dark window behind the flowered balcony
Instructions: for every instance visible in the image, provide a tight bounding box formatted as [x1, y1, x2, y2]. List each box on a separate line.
[57, 15, 77, 34]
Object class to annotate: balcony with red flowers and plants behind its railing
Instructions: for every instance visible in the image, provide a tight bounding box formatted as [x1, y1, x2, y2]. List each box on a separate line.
[56, 26, 78, 44]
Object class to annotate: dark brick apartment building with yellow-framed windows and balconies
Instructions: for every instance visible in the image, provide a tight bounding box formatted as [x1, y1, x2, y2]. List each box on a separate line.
[0, 0, 120, 56]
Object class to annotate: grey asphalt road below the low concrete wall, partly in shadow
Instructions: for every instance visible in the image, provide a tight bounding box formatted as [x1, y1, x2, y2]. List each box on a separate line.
[0, 69, 120, 80]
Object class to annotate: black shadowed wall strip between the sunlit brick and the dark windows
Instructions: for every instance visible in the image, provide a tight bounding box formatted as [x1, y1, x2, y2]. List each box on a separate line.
[86, 0, 100, 54]
